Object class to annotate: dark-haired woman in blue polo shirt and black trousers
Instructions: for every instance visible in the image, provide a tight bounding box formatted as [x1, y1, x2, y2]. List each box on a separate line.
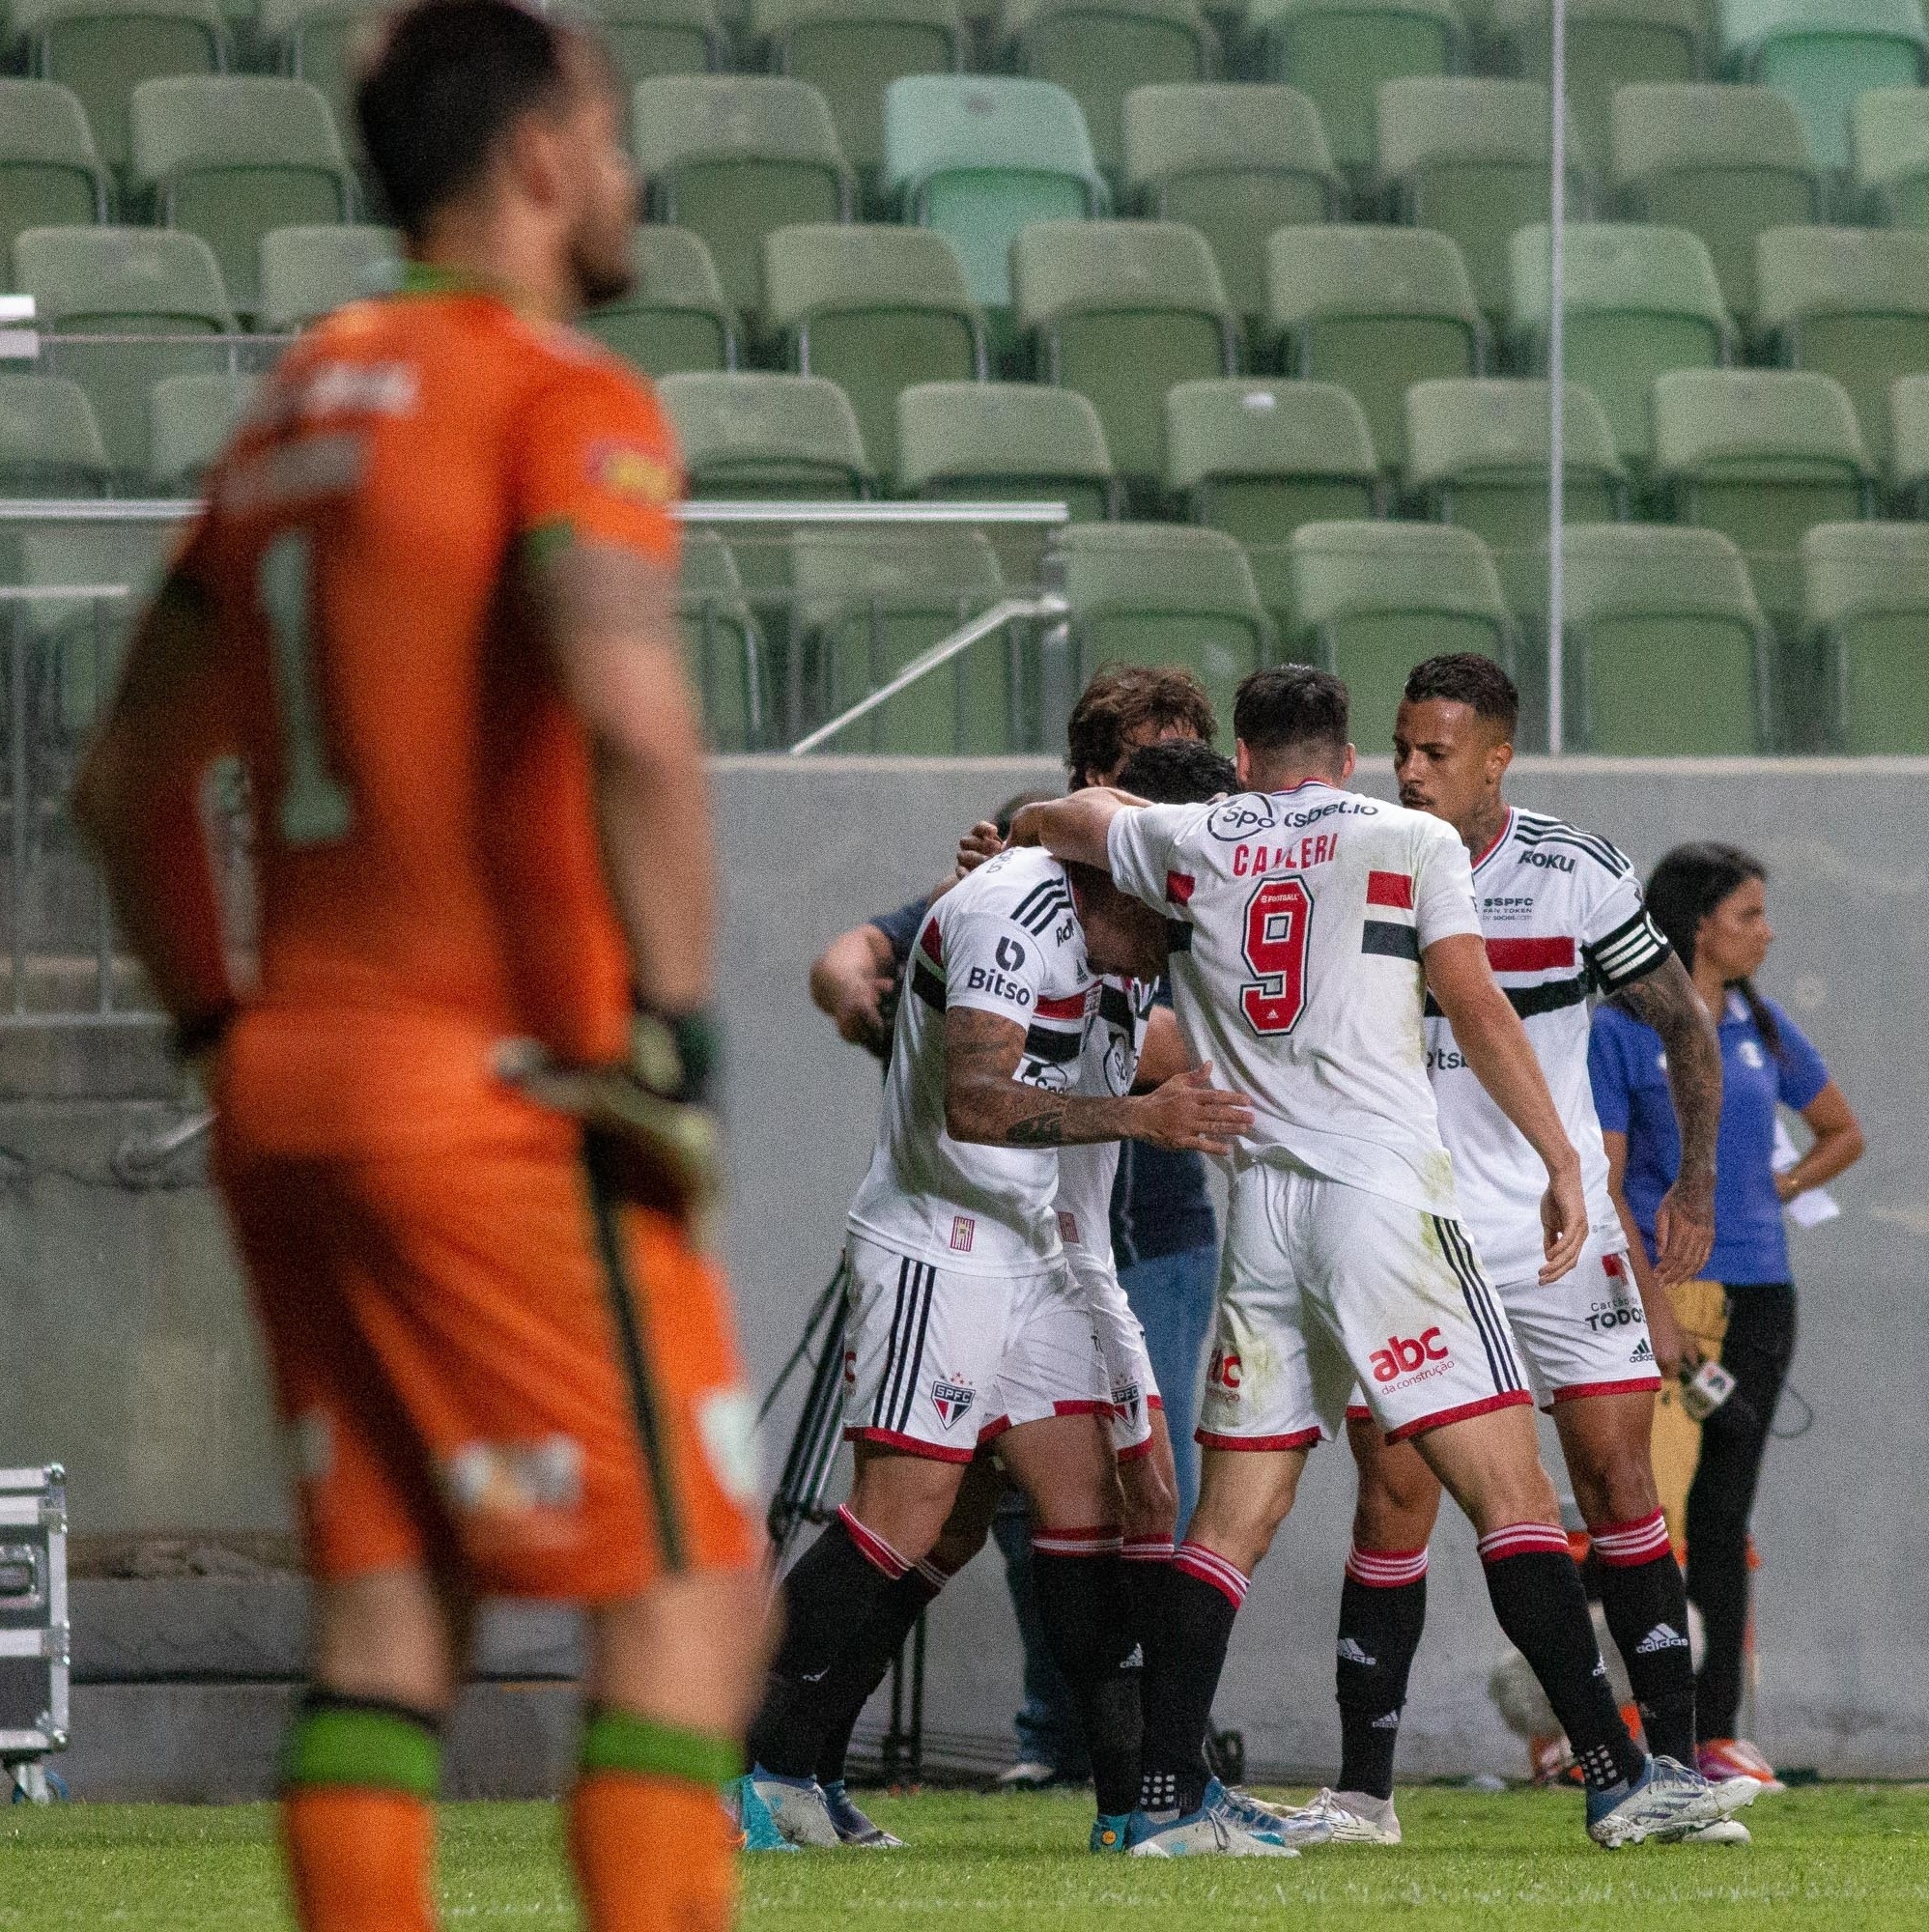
[1589, 844, 1861, 1789]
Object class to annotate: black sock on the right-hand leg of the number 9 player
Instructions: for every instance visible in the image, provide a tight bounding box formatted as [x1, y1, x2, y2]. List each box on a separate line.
[1481, 1522, 1647, 1791]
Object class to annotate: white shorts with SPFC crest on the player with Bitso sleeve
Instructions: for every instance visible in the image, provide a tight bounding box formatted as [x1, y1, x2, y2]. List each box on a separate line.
[844, 1235, 1112, 1463]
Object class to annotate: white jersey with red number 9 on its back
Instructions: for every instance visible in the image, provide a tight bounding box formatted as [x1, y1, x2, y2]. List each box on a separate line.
[1108, 781, 1481, 1217]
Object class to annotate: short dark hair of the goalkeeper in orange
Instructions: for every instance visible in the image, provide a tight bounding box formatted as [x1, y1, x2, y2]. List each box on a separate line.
[355, 0, 572, 240]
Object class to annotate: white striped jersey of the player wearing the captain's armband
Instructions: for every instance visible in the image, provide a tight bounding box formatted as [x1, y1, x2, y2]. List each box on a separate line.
[1427, 808, 1668, 1285]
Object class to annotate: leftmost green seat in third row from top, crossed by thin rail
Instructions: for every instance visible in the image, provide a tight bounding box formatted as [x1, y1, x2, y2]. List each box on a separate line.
[14, 228, 238, 477]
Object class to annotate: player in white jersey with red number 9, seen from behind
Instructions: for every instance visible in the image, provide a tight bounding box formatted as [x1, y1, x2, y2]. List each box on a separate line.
[1013, 665, 1762, 1857]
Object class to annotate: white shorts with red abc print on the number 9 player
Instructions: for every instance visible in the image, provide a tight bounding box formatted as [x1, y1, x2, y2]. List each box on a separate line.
[1199, 1161, 1533, 1449]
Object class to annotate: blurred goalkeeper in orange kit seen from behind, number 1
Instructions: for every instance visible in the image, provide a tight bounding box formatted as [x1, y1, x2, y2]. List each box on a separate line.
[75, 0, 761, 1932]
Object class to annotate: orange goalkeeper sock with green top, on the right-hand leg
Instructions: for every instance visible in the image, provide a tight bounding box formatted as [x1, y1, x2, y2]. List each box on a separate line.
[568, 1710, 742, 1932]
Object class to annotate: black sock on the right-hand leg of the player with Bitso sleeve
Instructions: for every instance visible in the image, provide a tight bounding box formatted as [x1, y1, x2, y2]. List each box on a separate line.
[1033, 1528, 1141, 1816]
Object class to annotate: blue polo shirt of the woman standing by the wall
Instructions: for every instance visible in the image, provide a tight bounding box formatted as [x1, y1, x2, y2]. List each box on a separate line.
[1587, 993, 1829, 1283]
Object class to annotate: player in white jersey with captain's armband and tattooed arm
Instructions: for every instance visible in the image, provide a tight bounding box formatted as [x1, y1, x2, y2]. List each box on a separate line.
[1288, 655, 1747, 1845]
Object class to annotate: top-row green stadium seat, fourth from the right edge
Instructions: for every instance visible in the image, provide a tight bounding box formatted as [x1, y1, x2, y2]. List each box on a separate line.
[1006, 0, 1220, 182]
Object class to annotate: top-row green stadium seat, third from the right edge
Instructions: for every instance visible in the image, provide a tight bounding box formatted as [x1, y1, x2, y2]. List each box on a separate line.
[1247, 0, 1467, 187]
